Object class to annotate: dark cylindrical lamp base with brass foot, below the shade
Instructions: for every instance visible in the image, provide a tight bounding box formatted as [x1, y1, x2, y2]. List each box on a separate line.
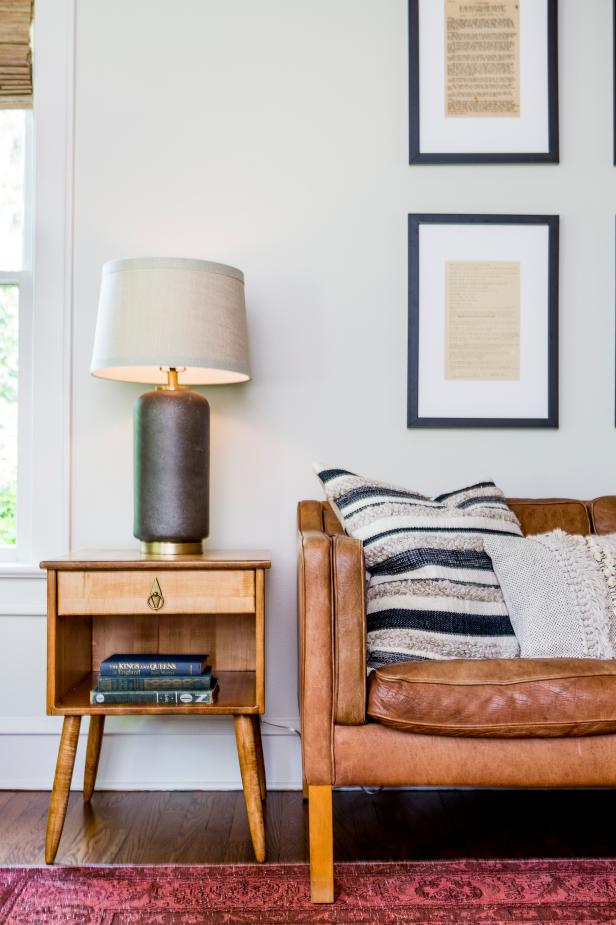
[133, 378, 210, 555]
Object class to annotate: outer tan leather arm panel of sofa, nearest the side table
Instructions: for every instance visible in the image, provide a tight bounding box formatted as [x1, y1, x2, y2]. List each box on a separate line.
[297, 501, 334, 785]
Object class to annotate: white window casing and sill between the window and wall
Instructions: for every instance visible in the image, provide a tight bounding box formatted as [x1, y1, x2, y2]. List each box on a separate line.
[0, 0, 75, 600]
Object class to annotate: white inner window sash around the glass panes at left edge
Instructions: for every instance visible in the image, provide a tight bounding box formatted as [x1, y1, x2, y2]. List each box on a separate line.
[0, 110, 34, 562]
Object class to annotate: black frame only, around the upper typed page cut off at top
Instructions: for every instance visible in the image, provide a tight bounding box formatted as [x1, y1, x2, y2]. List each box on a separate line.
[409, 0, 560, 164]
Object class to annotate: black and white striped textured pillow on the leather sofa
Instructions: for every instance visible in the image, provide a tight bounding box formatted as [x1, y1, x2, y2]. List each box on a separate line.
[315, 464, 522, 669]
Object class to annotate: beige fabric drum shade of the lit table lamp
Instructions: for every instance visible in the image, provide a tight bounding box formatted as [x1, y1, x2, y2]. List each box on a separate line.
[90, 257, 250, 385]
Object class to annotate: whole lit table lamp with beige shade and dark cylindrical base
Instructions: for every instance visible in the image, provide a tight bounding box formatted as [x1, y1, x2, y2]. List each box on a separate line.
[90, 257, 250, 555]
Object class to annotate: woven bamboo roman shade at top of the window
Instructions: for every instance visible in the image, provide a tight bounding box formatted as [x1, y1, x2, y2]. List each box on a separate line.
[0, 0, 34, 109]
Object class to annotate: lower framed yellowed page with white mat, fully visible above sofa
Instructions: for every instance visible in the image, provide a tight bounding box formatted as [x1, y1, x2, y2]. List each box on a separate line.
[407, 215, 559, 427]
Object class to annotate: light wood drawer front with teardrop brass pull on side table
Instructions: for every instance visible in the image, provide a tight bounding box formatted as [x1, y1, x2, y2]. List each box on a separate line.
[58, 569, 255, 616]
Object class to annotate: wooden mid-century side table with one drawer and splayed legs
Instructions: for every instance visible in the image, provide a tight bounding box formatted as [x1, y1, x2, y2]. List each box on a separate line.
[41, 550, 271, 864]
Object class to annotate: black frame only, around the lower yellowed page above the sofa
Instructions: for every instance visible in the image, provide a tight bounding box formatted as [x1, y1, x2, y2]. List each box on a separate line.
[407, 214, 560, 428]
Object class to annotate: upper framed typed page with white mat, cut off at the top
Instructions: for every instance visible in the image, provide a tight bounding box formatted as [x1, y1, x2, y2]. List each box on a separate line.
[409, 0, 558, 164]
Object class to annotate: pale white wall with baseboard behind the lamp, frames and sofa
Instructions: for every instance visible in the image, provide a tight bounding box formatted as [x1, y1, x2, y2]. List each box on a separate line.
[0, 0, 616, 786]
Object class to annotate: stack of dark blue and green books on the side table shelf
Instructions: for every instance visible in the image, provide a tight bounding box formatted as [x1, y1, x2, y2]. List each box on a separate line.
[90, 653, 218, 704]
